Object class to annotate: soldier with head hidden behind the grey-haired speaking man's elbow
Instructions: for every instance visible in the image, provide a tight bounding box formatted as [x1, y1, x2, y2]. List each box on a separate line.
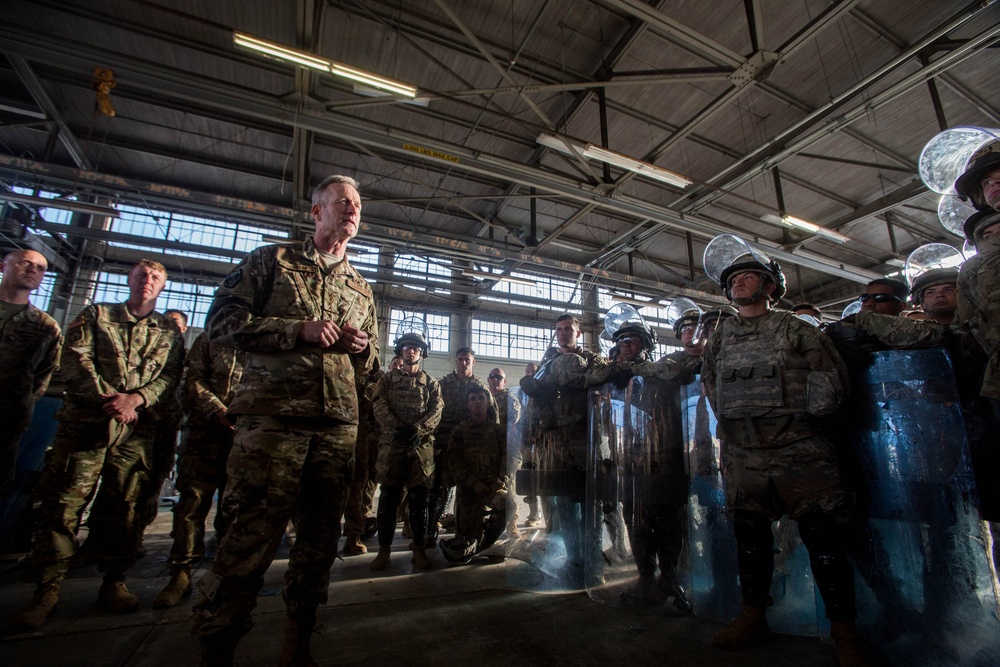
[153, 332, 245, 609]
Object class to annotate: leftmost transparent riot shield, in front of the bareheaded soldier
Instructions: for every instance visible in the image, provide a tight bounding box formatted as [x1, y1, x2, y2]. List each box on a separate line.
[503, 368, 600, 592]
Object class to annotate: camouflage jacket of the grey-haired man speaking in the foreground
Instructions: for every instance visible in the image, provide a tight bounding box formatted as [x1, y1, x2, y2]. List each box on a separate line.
[208, 238, 378, 424]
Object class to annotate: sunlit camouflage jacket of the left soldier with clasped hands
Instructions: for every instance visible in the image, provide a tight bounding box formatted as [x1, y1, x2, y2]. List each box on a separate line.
[59, 303, 184, 422]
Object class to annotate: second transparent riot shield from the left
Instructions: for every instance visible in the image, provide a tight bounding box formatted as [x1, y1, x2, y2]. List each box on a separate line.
[585, 377, 691, 615]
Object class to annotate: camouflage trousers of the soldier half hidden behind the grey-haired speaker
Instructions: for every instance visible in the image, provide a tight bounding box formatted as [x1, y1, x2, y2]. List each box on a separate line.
[170, 424, 233, 568]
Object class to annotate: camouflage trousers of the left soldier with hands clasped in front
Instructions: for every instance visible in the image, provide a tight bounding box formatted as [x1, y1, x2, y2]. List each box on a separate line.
[25, 420, 152, 584]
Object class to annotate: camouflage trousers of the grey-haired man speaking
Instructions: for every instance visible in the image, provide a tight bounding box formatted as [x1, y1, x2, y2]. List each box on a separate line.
[191, 415, 358, 638]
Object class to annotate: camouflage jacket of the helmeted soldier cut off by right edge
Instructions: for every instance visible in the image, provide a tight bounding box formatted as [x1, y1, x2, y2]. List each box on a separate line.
[957, 243, 1000, 399]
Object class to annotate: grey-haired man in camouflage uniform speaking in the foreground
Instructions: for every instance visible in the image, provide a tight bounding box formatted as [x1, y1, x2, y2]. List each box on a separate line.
[191, 176, 378, 665]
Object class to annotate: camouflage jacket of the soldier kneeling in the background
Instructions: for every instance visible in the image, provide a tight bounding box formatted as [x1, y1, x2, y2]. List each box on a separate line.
[448, 420, 507, 496]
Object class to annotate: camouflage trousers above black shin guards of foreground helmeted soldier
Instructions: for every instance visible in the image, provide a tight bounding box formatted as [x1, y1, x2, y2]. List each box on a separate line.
[723, 435, 854, 520]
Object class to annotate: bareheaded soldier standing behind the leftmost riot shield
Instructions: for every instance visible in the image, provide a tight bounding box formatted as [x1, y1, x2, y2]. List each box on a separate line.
[521, 314, 608, 582]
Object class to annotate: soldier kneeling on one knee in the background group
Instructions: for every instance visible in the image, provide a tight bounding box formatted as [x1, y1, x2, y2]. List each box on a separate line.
[442, 386, 508, 560]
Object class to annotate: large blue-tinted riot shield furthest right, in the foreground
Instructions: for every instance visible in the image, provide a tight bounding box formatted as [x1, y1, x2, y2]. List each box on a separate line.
[845, 349, 1000, 665]
